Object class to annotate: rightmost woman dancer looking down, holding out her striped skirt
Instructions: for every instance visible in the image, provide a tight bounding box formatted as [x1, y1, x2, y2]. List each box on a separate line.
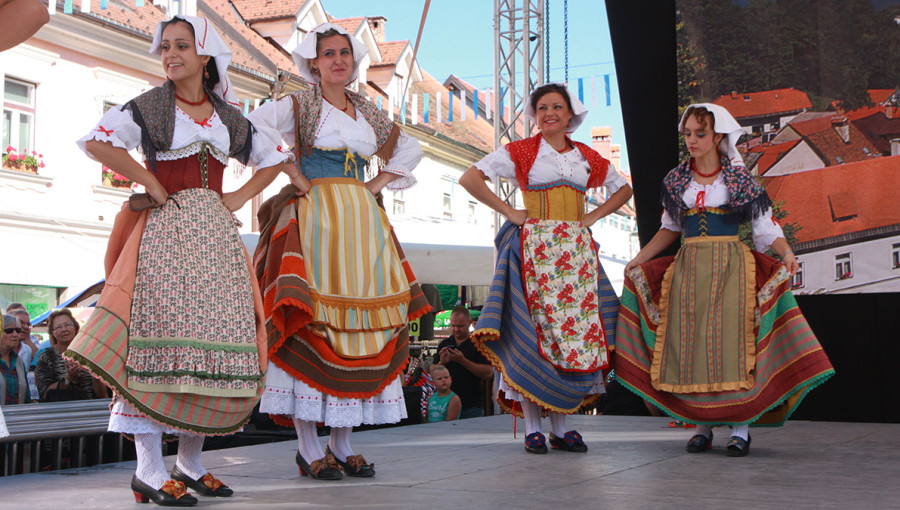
[616, 104, 834, 457]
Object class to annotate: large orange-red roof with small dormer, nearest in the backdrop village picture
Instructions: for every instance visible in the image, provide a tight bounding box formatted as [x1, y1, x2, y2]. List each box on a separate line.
[763, 156, 900, 242]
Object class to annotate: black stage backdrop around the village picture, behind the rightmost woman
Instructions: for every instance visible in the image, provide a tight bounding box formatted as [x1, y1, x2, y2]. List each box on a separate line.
[606, 0, 900, 423]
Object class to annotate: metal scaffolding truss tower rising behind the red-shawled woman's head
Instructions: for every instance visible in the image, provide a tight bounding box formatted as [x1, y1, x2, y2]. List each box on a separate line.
[493, 0, 545, 147]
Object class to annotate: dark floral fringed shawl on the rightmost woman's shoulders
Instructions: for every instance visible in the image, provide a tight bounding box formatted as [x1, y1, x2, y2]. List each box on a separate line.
[660, 157, 772, 225]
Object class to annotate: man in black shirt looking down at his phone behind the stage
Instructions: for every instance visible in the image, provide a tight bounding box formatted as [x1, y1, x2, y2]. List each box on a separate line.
[433, 305, 493, 419]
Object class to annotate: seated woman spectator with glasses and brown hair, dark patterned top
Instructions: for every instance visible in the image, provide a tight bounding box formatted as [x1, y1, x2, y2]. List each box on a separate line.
[34, 308, 106, 402]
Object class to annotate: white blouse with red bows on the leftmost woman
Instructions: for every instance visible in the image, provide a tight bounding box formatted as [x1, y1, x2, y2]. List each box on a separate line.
[76, 106, 287, 168]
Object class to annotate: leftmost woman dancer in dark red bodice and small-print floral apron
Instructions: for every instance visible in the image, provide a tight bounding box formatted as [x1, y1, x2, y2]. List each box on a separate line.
[65, 16, 285, 506]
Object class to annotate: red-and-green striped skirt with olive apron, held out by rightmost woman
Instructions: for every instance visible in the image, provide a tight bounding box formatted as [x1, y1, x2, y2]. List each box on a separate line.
[615, 236, 834, 426]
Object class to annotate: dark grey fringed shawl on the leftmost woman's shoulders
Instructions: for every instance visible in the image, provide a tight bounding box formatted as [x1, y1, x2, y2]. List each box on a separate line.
[124, 80, 253, 172]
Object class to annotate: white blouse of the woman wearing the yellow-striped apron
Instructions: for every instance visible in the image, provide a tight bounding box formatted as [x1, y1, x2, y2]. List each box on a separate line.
[249, 96, 422, 191]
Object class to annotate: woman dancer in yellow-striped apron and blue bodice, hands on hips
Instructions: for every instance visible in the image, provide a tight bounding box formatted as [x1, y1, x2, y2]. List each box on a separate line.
[251, 23, 430, 480]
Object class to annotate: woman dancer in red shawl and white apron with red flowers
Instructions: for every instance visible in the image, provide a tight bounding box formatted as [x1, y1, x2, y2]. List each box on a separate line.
[459, 83, 632, 453]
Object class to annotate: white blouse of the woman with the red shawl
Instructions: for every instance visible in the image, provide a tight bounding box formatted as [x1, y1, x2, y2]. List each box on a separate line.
[475, 138, 628, 194]
